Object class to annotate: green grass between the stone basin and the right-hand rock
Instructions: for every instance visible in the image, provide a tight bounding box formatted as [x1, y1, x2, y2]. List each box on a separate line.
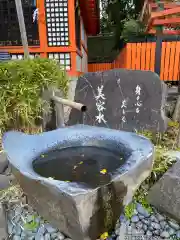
[125, 122, 179, 218]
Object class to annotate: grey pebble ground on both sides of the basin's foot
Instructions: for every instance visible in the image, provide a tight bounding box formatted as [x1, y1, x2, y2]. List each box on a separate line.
[8, 201, 180, 240]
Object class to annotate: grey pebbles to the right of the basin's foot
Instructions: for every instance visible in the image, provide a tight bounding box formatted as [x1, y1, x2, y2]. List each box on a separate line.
[116, 203, 180, 240]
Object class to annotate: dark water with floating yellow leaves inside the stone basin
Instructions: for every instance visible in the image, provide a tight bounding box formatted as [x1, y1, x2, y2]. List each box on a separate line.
[33, 146, 125, 188]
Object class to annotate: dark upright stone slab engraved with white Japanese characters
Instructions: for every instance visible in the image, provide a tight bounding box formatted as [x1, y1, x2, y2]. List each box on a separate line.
[68, 69, 167, 131]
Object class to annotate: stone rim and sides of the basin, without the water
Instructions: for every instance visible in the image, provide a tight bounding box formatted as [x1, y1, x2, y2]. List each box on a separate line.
[3, 125, 153, 240]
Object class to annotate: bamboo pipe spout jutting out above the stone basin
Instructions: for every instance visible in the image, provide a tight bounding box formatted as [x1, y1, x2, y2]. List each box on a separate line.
[51, 95, 87, 112]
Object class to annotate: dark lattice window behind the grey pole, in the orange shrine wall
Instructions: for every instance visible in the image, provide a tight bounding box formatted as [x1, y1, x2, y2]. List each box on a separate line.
[0, 0, 39, 46]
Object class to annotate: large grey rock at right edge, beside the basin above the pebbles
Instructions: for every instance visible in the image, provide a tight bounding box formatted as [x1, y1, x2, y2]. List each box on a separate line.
[148, 158, 180, 221]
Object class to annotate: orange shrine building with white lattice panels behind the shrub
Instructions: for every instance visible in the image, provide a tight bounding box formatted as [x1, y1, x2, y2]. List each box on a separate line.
[0, 0, 100, 77]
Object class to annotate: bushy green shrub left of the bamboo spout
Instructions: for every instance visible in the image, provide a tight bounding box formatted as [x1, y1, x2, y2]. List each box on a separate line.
[0, 58, 68, 133]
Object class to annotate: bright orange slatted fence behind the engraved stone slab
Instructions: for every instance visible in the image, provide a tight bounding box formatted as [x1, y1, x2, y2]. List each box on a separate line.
[88, 38, 180, 81]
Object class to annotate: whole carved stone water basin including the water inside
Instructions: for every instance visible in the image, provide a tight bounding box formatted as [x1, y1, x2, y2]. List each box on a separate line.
[3, 125, 154, 240]
